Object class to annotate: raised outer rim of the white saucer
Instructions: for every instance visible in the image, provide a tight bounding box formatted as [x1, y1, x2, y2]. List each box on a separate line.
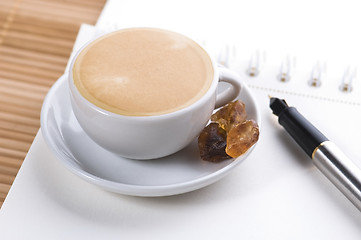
[40, 73, 261, 197]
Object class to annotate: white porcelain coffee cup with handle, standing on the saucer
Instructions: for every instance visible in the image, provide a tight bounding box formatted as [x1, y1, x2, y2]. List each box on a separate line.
[68, 28, 241, 159]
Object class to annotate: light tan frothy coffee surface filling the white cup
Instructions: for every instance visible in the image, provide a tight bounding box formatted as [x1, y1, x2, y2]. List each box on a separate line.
[72, 28, 214, 116]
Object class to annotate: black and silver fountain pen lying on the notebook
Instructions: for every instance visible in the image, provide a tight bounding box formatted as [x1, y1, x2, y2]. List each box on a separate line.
[270, 97, 361, 211]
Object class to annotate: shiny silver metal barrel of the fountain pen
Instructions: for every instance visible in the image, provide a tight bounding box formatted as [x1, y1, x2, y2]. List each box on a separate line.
[312, 141, 361, 211]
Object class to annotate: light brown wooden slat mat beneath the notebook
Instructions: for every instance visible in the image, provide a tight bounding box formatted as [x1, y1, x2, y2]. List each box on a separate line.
[0, 0, 106, 207]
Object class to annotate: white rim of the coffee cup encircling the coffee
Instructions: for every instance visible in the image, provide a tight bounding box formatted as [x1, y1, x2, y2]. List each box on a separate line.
[68, 27, 219, 120]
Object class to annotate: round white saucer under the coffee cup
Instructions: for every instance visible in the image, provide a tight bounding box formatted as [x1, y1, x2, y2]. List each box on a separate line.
[41, 75, 261, 196]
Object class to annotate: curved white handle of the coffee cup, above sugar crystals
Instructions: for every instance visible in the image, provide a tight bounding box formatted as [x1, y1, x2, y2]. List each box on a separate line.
[215, 68, 242, 108]
